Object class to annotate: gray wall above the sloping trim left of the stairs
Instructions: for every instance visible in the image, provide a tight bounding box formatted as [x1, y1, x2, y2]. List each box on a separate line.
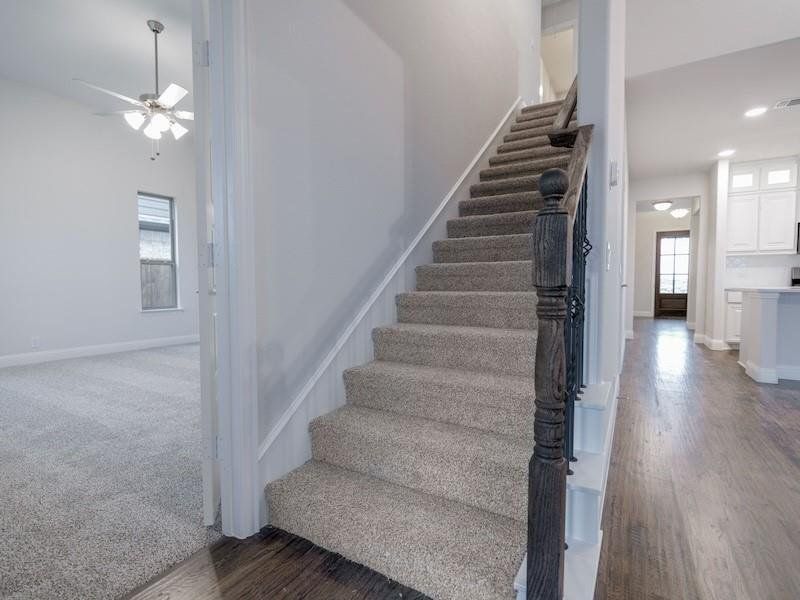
[247, 0, 539, 437]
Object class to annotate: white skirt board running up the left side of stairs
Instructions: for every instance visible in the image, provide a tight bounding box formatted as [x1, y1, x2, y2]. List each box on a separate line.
[257, 98, 522, 523]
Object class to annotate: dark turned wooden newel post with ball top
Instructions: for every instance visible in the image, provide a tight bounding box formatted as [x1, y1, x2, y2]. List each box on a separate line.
[527, 169, 572, 600]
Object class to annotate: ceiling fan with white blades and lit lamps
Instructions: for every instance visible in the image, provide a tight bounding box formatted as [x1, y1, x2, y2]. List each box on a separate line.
[75, 20, 194, 160]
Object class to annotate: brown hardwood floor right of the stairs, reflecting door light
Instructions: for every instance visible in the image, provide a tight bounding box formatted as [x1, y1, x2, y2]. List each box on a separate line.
[595, 319, 800, 600]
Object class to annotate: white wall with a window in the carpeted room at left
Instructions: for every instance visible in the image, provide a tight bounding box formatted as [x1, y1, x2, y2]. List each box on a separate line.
[0, 80, 198, 363]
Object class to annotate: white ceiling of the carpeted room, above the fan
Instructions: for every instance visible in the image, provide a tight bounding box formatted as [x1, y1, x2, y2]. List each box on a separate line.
[0, 0, 192, 111]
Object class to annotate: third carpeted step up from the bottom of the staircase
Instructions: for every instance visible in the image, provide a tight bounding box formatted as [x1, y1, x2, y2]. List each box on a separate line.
[344, 361, 534, 442]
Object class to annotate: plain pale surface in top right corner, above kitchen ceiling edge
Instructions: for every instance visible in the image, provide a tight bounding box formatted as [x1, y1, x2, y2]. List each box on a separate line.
[626, 0, 800, 77]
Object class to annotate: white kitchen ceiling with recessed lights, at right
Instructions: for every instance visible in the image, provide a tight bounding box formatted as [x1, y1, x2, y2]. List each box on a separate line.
[626, 35, 800, 178]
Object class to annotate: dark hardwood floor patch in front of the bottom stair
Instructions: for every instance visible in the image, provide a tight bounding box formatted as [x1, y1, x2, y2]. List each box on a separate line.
[126, 528, 430, 600]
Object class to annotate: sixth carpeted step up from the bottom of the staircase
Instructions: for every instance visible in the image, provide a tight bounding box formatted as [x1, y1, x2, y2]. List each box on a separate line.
[416, 260, 533, 292]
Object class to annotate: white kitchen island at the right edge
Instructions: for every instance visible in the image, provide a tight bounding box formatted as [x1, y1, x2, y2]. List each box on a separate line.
[726, 286, 800, 383]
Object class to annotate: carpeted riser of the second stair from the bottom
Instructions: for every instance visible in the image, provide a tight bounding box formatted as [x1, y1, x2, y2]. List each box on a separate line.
[310, 423, 527, 521]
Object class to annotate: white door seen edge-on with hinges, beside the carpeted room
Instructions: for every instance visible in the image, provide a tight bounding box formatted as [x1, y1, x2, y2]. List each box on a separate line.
[192, 0, 220, 525]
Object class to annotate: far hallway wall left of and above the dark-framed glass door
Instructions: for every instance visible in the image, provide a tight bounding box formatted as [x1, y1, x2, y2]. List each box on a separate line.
[633, 208, 694, 317]
